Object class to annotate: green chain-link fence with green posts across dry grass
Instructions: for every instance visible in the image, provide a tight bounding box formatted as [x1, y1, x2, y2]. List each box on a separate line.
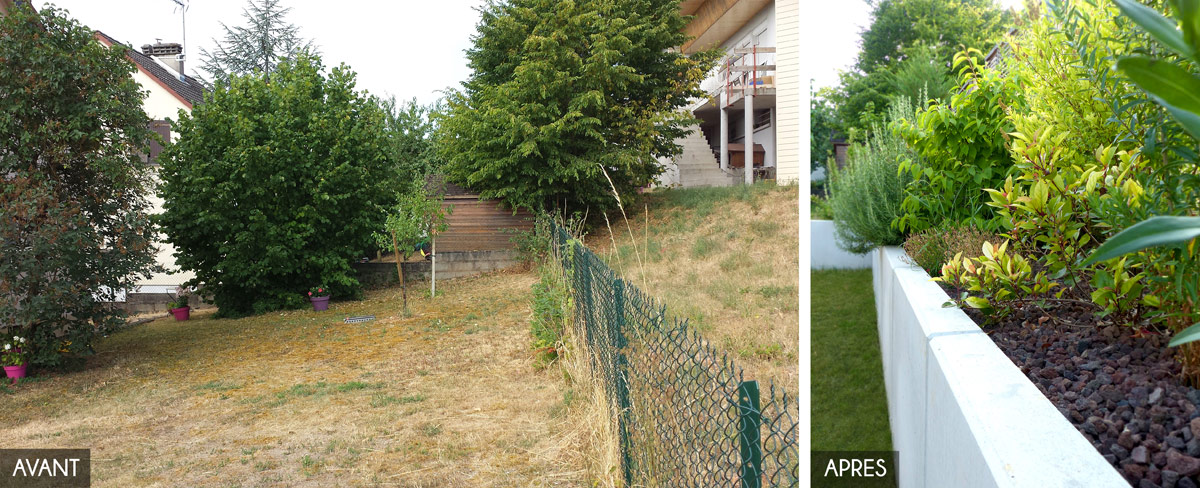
[553, 225, 799, 488]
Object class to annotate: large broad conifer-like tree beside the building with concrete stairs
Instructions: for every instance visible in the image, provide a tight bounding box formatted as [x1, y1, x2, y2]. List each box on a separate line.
[439, 0, 715, 215]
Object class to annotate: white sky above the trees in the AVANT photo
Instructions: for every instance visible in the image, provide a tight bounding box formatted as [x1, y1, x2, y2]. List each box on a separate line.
[34, 0, 485, 104]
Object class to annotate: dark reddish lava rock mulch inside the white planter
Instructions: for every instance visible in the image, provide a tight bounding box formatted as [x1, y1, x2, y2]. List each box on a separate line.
[968, 299, 1200, 488]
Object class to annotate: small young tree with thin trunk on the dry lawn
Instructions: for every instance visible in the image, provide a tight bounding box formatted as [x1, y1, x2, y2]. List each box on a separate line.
[376, 186, 448, 309]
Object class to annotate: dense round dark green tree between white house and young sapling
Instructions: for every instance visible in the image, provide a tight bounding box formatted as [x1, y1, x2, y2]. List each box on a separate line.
[162, 54, 400, 315]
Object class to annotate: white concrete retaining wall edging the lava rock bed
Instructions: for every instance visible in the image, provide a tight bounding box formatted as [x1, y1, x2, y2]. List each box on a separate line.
[873, 248, 1129, 488]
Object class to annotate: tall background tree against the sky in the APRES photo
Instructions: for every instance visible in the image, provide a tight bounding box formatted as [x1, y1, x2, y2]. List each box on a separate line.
[838, 0, 1014, 129]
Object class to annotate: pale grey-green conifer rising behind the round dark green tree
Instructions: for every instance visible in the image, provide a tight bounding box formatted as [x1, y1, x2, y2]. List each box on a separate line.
[200, 0, 314, 84]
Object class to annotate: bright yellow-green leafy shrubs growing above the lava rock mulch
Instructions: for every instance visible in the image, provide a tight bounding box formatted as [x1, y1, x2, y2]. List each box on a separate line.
[921, 0, 1198, 340]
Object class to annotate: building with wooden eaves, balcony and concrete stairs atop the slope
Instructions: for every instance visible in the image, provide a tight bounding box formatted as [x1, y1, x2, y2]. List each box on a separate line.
[659, 0, 800, 187]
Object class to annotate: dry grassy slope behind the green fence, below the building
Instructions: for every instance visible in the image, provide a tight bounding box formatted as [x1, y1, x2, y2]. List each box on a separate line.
[588, 182, 799, 393]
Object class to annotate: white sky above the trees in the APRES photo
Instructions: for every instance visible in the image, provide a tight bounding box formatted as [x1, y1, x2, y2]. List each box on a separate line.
[800, 0, 1022, 89]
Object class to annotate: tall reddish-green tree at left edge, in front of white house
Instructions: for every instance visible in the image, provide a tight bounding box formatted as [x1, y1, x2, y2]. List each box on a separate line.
[0, 6, 155, 366]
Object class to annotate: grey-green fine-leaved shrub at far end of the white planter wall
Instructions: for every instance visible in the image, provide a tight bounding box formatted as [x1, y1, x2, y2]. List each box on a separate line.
[829, 97, 916, 253]
